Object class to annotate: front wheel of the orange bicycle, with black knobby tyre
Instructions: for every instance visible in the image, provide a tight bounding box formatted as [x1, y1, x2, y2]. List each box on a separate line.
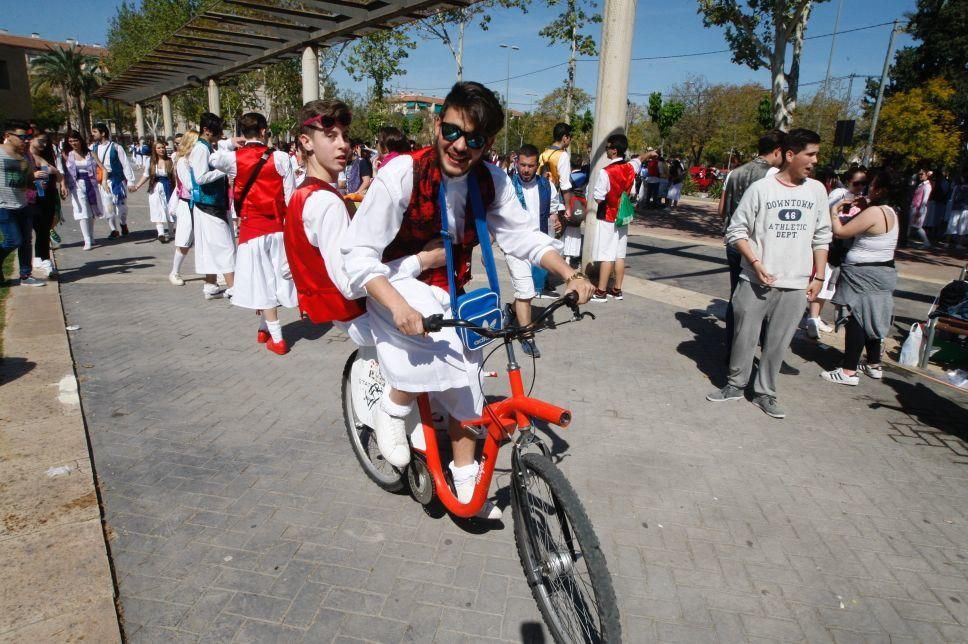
[511, 453, 622, 643]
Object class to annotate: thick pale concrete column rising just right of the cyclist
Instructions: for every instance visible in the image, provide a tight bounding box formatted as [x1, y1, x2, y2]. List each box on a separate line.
[582, 0, 636, 265]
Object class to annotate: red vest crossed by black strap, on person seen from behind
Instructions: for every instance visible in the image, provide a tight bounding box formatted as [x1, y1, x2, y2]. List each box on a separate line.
[234, 143, 286, 244]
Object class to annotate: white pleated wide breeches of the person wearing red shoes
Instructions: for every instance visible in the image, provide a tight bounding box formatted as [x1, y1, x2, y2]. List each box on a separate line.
[232, 233, 298, 309]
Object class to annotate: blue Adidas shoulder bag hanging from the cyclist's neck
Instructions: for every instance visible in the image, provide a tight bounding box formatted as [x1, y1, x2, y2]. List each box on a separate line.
[438, 173, 504, 349]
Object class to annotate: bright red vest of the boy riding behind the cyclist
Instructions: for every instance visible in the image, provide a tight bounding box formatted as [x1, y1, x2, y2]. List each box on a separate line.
[283, 177, 366, 324]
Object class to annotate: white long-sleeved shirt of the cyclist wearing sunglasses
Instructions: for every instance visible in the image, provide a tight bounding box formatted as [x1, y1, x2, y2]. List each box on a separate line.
[342, 155, 561, 290]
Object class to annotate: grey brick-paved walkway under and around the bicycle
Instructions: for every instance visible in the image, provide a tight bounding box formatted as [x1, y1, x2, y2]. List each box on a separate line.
[49, 195, 968, 643]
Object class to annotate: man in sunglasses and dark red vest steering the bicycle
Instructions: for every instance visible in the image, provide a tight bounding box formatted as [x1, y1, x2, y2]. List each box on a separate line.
[342, 82, 594, 519]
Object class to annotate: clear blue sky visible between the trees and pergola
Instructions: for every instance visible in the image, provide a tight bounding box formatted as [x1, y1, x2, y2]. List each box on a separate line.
[0, 0, 915, 110]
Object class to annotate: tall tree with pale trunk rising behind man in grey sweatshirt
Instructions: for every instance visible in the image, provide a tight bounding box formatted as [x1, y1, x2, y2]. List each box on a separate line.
[699, 0, 827, 131]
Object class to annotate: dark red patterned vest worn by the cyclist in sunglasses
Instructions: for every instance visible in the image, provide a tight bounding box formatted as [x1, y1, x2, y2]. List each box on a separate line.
[383, 146, 494, 291]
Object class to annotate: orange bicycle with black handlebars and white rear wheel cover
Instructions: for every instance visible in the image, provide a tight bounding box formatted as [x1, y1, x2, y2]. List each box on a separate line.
[343, 293, 621, 642]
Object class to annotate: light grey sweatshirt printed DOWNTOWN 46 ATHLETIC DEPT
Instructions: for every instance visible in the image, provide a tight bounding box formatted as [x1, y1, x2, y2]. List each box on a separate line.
[726, 175, 833, 289]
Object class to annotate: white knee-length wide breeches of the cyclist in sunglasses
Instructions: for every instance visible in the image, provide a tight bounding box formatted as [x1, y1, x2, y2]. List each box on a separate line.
[366, 278, 484, 420]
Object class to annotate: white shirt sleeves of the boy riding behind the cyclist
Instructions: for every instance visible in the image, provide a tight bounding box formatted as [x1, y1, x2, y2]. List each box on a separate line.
[303, 184, 423, 300]
